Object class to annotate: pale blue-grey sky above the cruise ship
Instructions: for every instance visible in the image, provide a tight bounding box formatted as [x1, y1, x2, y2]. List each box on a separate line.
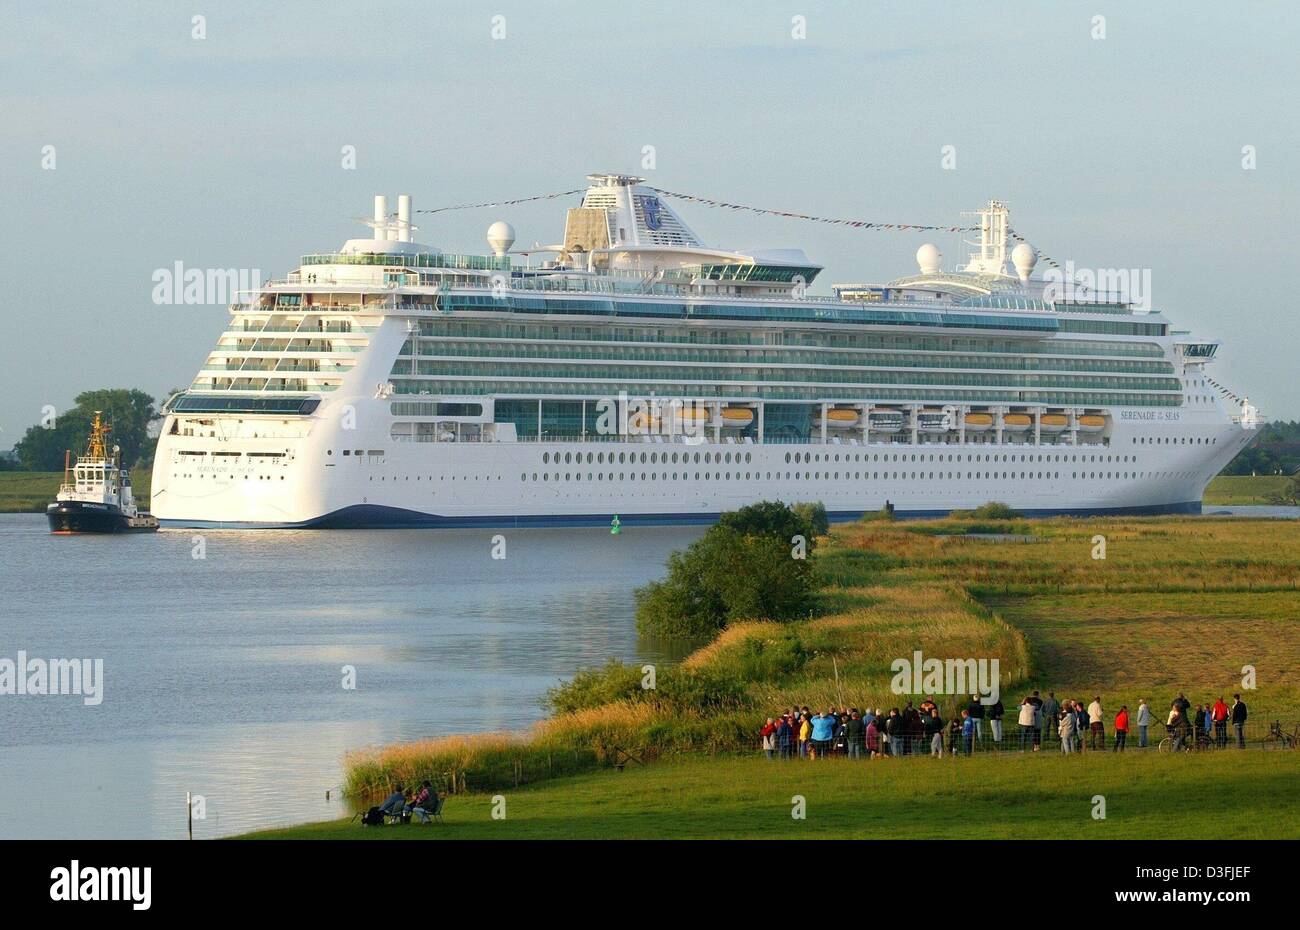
[0, 0, 1300, 449]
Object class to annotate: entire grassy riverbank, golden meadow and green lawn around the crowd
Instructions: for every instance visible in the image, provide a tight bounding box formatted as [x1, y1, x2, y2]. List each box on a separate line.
[244, 518, 1300, 838]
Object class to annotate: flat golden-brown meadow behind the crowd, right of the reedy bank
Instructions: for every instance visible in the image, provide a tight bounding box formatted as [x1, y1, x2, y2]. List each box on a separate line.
[824, 518, 1300, 722]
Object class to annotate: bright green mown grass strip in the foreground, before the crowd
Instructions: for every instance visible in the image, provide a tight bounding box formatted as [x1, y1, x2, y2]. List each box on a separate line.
[250, 749, 1300, 839]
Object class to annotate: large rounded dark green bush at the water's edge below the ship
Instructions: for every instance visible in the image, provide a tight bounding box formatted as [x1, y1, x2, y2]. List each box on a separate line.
[636, 502, 815, 639]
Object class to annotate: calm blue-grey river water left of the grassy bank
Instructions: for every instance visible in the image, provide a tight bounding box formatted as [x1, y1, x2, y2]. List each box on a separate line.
[0, 514, 702, 838]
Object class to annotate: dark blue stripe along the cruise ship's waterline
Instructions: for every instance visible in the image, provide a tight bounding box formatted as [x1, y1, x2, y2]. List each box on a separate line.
[161, 501, 1201, 529]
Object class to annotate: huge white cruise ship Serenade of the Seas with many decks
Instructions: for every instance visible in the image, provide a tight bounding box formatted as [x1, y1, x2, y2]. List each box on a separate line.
[152, 174, 1258, 528]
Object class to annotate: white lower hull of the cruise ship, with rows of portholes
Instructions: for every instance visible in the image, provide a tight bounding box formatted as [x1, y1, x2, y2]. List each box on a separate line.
[152, 407, 1255, 528]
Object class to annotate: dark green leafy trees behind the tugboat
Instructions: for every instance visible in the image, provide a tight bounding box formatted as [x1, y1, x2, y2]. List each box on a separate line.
[14, 388, 159, 471]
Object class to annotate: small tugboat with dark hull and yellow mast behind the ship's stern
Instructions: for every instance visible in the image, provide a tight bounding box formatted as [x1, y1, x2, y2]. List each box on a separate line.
[46, 410, 159, 533]
